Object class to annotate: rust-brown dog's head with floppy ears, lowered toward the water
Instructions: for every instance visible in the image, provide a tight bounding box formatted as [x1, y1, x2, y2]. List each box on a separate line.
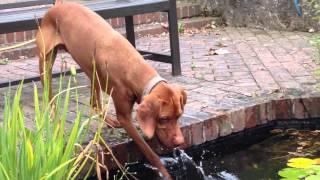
[137, 83, 187, 148]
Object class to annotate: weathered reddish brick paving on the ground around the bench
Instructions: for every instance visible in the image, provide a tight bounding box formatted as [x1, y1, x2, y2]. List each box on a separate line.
[0, 27, 319, 149]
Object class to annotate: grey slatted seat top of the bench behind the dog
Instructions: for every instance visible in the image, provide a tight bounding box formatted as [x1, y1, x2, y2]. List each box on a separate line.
[0, 0, 169, 34]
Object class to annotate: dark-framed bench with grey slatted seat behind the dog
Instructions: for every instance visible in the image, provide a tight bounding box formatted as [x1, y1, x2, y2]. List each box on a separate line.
[0, 0, 181, 84]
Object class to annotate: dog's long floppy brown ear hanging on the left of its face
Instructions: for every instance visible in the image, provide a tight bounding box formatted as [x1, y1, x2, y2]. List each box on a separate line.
[137, 96, 160, 139]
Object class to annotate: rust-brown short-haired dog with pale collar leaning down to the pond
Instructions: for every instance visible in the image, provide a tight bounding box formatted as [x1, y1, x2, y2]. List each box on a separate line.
[36, 3, 187, 178]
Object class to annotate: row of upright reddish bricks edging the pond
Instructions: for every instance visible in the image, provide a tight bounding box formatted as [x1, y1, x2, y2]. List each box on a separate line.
[108, 94, 320, 166]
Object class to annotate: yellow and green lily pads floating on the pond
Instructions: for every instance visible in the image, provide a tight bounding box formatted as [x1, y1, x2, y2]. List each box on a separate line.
[278, 158, 320, 180]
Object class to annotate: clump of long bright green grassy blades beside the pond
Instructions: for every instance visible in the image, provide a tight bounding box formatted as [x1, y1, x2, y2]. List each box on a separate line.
[0, 76, 88, 180]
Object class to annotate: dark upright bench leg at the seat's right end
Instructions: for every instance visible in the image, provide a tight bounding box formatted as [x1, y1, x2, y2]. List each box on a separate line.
[168, 0, 181, 76]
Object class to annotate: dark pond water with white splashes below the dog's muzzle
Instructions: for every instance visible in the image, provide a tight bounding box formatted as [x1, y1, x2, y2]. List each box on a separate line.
[110, 120, 320, 180]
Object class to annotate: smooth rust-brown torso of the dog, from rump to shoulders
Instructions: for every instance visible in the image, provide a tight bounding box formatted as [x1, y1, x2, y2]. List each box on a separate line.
[37, 2, 157, 92]
